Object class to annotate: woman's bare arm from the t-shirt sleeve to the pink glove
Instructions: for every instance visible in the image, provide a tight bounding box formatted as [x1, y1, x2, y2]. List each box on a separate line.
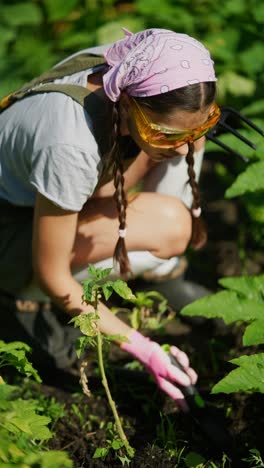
[33, 194, 131, 336]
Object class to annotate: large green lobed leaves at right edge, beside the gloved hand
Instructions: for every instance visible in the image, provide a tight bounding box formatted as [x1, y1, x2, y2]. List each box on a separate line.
[181, 275, 264, 393]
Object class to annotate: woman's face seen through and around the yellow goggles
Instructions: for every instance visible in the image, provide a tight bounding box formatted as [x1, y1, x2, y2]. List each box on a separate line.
[121, 96, 211, 162]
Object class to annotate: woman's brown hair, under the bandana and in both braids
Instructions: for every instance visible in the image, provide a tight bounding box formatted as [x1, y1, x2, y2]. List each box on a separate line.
[108, 82, 216, 275]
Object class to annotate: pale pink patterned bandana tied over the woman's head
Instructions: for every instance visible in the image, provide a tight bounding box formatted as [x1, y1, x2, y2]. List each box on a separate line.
[103, 29, 216, 102]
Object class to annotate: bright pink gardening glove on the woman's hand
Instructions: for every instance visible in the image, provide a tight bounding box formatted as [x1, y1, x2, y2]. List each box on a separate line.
[121, 330, 197, 411]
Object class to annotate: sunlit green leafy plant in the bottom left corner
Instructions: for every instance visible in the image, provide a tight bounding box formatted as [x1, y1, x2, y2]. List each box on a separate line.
[0, 341, 72, 468]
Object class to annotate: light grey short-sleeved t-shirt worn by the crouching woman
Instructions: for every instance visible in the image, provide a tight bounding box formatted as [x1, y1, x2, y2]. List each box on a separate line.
[0, 48, 108, 211]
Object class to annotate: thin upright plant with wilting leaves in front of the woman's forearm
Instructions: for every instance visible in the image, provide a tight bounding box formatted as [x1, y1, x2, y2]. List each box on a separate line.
[70, 265, 134, 458]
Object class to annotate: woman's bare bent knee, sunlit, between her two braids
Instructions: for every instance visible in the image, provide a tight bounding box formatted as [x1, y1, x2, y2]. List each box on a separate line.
[155, 197, 192, 258]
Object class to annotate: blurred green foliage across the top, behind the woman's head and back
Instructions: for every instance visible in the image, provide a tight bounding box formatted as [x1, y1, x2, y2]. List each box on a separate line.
[0, 0, 264, 113]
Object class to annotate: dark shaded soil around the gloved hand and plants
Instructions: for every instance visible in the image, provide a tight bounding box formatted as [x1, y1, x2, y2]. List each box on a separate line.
[7, 154, 264, 468]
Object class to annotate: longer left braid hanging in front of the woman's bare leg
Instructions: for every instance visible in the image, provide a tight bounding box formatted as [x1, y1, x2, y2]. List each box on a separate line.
[111, 104, 130, 275]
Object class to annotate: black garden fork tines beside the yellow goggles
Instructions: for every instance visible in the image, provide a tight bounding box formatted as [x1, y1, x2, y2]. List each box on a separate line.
[206, 107, 264, 161]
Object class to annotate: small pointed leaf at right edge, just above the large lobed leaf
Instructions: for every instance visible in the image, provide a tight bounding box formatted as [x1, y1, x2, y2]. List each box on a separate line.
[218, 275, 264, 303]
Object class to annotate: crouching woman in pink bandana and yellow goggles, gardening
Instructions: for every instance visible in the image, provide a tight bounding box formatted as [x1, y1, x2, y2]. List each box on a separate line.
[0, 29, 220, 409]
